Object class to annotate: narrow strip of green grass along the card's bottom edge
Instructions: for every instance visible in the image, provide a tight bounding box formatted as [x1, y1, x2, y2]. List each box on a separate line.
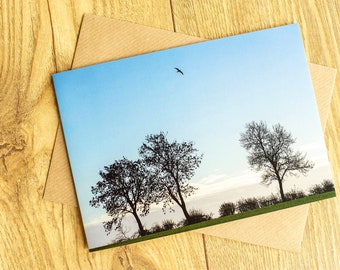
[90, 191, 336, 252]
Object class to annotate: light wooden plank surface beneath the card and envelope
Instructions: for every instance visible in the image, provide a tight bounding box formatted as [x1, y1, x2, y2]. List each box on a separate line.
[0, 0, 340, 270]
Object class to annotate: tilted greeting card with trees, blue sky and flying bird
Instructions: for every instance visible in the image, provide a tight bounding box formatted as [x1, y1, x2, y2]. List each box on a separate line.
[53, 24, 335, 251]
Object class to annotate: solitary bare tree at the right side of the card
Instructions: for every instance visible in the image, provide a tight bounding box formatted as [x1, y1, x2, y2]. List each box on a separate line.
[240, 121, 314, 201]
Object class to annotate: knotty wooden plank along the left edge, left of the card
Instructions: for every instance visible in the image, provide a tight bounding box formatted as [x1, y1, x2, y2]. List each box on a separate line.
[0, 1, 63, 269]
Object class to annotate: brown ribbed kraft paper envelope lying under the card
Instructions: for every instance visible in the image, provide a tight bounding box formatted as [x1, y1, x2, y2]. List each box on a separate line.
[44, 15, 336, 251]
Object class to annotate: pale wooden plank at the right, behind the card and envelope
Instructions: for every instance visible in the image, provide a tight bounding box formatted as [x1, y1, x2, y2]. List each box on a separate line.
[172, 0, 340, 269]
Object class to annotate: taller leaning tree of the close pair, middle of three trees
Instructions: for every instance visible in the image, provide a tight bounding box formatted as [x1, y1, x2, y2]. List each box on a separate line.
[139, 132, 203, 224]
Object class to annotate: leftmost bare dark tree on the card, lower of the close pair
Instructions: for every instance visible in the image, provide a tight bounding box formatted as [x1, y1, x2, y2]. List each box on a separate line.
[90, 158, 152, 236]
